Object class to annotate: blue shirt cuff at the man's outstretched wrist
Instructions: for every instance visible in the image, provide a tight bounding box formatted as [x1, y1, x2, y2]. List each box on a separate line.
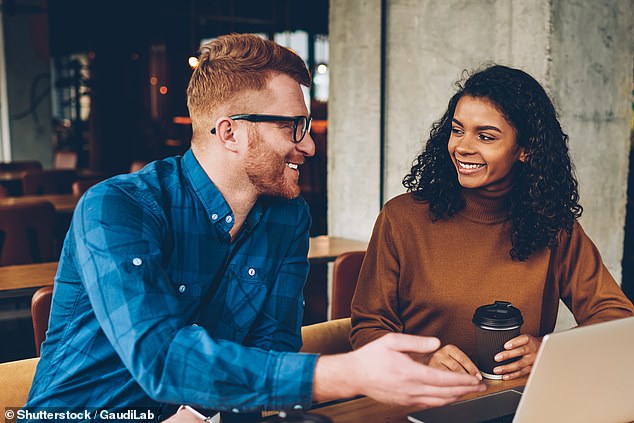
[269, 353, 319, 410]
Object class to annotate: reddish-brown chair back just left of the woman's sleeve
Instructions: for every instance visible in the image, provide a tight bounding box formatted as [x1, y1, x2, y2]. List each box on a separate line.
[330, 251, 365, 319]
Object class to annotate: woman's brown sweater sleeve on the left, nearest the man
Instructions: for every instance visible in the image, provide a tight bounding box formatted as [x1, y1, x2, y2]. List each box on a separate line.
[350, 207, 403, 349]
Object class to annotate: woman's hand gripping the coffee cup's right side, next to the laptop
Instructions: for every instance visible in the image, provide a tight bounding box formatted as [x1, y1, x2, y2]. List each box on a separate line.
[493, 334, 542, 380]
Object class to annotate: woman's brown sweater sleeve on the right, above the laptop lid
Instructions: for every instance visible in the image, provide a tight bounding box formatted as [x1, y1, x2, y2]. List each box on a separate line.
[557, 222, 634, 325]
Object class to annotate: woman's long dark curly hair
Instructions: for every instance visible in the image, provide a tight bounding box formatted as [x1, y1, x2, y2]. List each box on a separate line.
[403, 65, 583, 260]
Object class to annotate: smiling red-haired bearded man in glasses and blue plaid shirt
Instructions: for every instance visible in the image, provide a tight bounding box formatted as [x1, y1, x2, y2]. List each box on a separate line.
[25, 34, 483, 419]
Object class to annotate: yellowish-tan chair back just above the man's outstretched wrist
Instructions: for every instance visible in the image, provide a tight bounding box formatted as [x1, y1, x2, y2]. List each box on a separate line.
[300, 318, 352, 354]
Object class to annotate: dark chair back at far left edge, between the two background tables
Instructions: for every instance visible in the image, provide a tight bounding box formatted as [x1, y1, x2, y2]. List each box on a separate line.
[0, 201, 56, 266]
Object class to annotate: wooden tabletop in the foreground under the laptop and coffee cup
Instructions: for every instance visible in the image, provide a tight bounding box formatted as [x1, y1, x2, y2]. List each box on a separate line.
[312, 376, 528, 423]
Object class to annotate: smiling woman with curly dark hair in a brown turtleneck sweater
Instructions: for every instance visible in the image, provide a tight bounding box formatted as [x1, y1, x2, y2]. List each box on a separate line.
[351, 65, 634, 379]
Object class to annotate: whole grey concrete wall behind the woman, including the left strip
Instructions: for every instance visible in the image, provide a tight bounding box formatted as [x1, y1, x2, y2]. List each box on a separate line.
[328, 0, 634, 328]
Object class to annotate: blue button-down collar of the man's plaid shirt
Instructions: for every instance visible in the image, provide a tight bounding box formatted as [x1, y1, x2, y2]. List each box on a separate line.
[183, 149, 262, 231]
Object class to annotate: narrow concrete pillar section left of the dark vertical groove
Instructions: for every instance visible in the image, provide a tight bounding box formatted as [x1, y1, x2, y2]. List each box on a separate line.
[328, 0, 381, 240]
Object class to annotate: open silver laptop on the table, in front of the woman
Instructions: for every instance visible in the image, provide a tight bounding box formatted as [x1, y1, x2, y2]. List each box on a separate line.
[407, 317, 634, 423]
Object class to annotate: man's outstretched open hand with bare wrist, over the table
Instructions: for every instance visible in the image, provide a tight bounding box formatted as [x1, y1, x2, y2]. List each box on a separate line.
[313, 333, 486, 408]
